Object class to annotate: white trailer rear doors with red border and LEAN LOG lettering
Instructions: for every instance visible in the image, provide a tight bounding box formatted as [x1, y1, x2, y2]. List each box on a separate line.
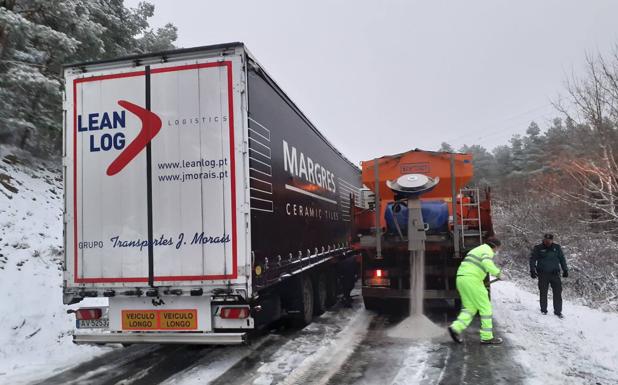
[65, 55, 248, 287]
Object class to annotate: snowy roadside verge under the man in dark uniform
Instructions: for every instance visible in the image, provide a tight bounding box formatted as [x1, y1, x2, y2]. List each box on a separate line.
[492, 281, 618, 385]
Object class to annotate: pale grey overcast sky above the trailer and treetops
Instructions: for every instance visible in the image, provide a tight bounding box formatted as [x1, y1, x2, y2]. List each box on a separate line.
[126, 0, 618, 163]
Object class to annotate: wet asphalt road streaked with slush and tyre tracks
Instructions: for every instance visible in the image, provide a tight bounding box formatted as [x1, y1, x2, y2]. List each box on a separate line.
[31, 297, 524, 385]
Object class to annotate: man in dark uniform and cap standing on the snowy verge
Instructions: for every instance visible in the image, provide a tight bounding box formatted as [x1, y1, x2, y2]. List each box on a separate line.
[530, 234, 569, 318]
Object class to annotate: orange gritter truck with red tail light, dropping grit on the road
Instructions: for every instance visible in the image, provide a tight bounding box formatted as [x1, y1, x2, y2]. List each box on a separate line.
[355, 150, 493, 310]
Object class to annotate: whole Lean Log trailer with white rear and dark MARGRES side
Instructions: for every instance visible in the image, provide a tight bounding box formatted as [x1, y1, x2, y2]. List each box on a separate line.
[63, 43, 361, 344]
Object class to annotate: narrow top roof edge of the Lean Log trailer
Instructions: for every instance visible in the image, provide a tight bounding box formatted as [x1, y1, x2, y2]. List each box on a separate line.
[63, 42, 360, 172]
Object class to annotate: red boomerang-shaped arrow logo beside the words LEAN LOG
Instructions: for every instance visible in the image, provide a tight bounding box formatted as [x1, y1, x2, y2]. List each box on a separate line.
[107, 100, 162, 176]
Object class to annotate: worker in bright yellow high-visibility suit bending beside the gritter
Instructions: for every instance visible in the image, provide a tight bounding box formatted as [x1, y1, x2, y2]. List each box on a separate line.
[448, 238, 502, 345]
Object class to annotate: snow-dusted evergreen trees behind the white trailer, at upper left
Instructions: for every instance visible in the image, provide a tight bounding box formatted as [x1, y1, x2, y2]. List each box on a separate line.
[0, 0, 176, 155]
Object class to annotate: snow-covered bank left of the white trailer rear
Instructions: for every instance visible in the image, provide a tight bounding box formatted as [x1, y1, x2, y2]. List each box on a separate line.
[0, 147, 109, 384]
